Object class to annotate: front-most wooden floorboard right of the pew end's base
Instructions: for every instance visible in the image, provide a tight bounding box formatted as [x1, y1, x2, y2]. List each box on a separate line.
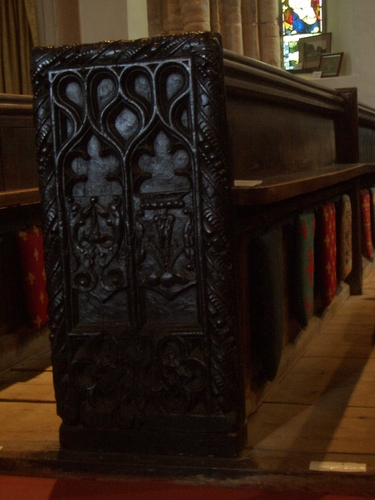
[249, 404, 375, 456]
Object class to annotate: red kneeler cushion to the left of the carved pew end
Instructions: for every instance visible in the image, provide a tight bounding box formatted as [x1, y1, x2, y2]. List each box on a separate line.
[17, 226, 48, 329]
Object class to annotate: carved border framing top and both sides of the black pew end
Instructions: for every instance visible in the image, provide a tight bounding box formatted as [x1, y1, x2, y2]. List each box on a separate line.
[32, 33, 245, 454]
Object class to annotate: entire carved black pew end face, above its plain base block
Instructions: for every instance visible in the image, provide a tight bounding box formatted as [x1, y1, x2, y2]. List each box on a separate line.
[33, 33, 243, 434]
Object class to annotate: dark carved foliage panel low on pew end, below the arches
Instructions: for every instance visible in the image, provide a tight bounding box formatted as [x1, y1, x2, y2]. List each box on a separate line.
[66, 333, 208, 428]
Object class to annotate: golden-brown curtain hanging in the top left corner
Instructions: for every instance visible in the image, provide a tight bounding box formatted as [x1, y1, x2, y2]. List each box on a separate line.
[0, 0, 38, 94]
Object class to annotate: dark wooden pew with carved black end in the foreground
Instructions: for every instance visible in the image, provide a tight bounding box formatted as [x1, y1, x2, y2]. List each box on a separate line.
[33, 33, 375, 456]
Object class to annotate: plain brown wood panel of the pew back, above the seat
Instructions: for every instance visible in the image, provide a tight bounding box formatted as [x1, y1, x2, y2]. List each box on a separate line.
[227, 98, 336, 179]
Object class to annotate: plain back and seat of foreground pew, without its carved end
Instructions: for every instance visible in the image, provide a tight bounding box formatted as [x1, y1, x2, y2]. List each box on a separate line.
[224, 51, 375, 409]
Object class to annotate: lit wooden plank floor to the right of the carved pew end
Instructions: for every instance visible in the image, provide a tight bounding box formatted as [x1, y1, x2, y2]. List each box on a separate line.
[248, 266, 375, 472]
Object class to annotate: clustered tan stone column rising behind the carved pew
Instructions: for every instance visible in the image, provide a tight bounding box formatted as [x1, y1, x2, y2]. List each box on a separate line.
[147, 0, 281, 67]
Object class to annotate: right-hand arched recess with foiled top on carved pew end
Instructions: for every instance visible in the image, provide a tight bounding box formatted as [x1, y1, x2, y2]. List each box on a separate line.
[134, 131, 197, 304]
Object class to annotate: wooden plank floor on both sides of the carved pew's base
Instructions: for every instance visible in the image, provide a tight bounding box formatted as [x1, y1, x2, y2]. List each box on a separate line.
[0, 270, 375, 498]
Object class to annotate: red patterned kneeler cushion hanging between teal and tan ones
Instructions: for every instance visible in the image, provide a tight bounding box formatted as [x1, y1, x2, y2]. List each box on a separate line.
[316, 203, 337, 308]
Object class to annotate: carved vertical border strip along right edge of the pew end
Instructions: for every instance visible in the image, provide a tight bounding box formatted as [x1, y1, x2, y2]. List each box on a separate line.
[195, 40, 240, 414]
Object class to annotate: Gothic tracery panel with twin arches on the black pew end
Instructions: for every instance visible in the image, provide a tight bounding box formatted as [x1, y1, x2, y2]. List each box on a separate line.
[50, 59, 200, 328]
